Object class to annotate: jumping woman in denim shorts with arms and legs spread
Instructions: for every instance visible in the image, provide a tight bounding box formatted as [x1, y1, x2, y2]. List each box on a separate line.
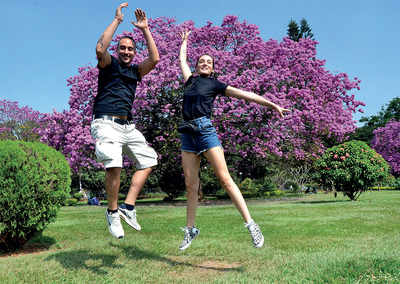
[178, 31, 289, 250]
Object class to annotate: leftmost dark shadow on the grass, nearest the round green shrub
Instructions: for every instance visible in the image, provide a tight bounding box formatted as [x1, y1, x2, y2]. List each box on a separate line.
[45, 249, 122, 275]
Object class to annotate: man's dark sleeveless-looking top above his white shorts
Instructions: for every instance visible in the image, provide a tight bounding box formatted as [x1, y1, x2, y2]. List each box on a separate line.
[93, 56, 141, 116]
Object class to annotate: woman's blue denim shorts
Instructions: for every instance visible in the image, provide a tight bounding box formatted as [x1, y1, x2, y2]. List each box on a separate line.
[181, 116, 221, 155]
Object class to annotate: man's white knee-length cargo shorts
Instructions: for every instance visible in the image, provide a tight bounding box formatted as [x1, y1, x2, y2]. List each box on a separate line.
[90, 118, 157, 170]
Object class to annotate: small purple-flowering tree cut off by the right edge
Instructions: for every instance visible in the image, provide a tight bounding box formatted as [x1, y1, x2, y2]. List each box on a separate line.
[371, 120, 400, 176]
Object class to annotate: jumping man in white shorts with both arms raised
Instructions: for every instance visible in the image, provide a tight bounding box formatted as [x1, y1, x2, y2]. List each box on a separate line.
[91, 3, 160, 239]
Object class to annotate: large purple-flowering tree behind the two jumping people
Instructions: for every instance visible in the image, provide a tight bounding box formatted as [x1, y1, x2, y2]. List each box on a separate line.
[37, 16, 364, 197]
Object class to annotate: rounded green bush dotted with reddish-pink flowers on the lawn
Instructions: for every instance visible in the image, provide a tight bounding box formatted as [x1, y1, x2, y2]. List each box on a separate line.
[315, 141, 390, 200]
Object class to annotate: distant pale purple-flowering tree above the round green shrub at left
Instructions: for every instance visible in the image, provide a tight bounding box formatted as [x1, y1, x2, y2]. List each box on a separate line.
[0, 100, 43, 141]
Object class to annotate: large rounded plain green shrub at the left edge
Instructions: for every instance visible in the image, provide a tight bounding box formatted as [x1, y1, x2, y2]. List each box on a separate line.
[0, 140, 71, 251]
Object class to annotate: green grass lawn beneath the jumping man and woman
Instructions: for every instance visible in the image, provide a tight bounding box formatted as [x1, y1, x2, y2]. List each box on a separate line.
[0, 191, 400, 283]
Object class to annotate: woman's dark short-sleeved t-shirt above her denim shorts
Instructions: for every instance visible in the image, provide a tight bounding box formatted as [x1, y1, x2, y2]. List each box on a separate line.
[182, 76, 228, 120]
